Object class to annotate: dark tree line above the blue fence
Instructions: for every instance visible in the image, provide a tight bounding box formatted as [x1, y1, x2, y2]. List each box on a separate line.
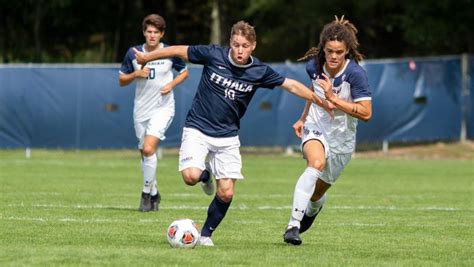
[0, 0, 474, 63]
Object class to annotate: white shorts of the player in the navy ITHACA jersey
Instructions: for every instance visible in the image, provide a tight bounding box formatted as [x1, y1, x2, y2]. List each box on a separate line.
[179, 128, 244, 179]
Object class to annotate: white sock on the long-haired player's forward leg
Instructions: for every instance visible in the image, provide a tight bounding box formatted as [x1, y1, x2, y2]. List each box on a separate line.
[288, 167, 321, 228]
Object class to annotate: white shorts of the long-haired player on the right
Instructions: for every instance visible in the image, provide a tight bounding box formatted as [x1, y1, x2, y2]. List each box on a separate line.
[301, 123, 352, 184]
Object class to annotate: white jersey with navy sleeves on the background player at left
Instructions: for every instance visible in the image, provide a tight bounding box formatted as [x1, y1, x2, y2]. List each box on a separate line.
[120, 43, 186, 122]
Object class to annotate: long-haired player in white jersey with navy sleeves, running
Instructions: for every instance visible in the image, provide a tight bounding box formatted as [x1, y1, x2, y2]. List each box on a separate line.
[283, 16, 372, 245]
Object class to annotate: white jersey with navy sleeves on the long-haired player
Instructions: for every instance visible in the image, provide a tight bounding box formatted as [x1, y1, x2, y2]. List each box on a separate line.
[306, 59, 372, 154]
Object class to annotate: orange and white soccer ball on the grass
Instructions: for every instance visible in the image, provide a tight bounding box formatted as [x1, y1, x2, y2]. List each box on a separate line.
[166, 219, 201, 248]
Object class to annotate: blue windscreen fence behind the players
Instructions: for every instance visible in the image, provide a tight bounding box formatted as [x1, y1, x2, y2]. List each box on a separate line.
[0, 56, 474, 149]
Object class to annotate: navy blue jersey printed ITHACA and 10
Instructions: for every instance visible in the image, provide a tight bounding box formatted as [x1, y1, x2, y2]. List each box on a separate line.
[185, 45, 285, 137]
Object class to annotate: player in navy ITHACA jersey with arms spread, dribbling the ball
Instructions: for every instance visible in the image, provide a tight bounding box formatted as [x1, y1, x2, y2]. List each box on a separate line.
[135, 21, 330, 246]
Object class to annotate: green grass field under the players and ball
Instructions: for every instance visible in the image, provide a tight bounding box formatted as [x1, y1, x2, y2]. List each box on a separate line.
[0, 150, 474, 266]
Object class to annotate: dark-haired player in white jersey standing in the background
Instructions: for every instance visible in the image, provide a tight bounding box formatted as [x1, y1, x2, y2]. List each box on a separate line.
[119, 14, 189, 212]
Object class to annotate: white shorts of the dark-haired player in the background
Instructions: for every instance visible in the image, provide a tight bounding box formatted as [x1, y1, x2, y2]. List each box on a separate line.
[134, 108, 174, 149]
